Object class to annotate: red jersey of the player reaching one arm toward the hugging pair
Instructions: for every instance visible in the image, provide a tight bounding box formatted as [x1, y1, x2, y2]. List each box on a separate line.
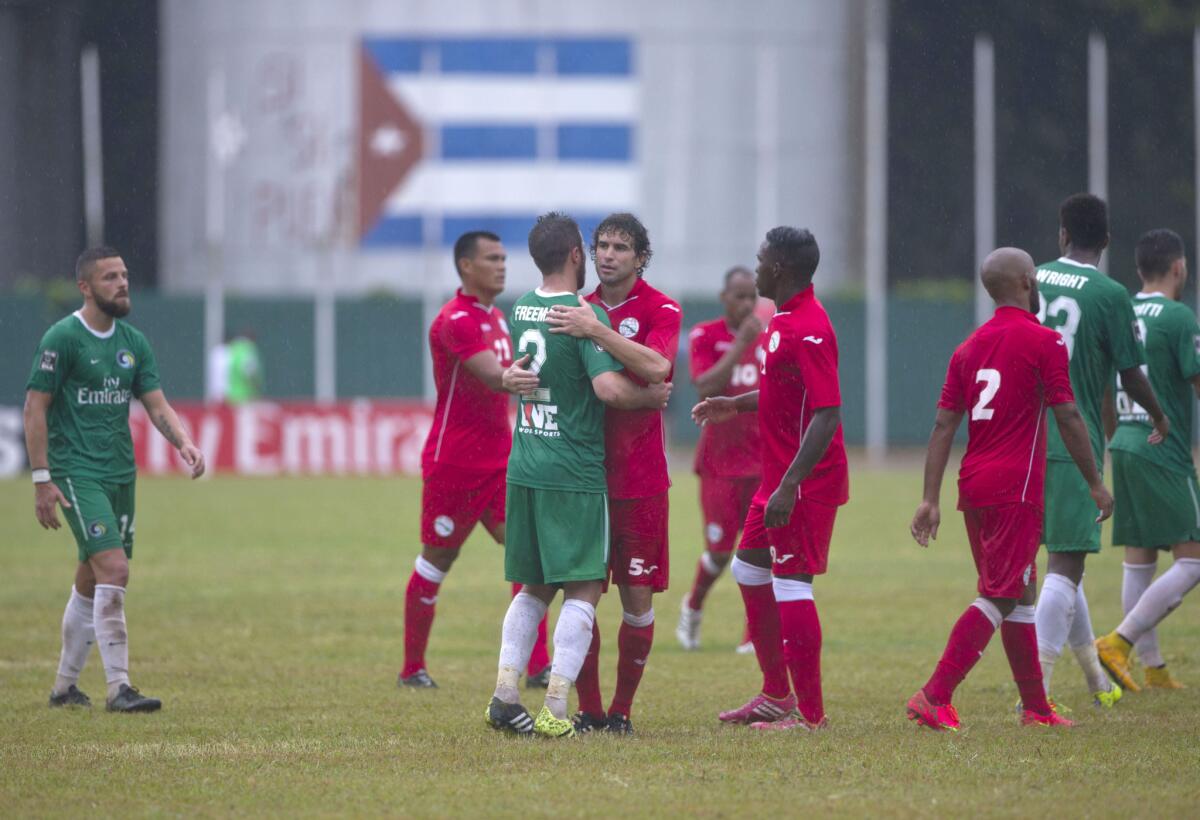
[755, 286, 850, 507]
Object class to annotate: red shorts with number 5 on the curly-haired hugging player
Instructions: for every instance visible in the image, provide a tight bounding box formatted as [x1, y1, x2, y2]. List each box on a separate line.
[608, 492, 671, 592]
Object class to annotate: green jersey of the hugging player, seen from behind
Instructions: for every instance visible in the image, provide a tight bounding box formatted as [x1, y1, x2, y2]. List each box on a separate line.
[508, 288, 622, 492]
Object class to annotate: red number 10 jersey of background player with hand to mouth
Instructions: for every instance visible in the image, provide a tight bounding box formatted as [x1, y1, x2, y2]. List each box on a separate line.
[688, 317, 767, 478]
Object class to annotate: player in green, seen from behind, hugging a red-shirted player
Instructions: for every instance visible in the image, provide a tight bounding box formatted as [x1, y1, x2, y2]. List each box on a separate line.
[485, 213, 671, 737]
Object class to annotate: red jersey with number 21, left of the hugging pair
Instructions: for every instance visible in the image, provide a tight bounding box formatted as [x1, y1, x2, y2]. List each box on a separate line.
[421, 289, 512, 475]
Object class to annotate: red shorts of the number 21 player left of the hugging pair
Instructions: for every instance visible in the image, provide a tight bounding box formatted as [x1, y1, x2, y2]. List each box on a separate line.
[421, 465, 505, 550]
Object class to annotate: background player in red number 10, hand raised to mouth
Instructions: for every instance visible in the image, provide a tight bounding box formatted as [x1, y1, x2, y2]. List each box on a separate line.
[676, 267, 766, 650]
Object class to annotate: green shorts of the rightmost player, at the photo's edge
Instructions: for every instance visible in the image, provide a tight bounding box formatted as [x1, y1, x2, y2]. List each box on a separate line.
[1112, 450, 1200, 550]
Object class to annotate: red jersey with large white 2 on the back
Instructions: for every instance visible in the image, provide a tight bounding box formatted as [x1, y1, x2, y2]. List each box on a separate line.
[937, 307, 1075, 509]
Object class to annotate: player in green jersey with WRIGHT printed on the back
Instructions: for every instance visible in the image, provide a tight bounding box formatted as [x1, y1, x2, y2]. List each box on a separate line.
[1036, 193, 1168, 706]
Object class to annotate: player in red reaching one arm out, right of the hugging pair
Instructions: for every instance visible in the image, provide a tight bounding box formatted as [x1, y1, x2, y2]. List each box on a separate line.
[691, 227, 850, 730]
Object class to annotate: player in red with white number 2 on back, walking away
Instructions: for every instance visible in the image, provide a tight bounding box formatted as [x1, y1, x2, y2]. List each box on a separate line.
[907, 247, 1112, 730]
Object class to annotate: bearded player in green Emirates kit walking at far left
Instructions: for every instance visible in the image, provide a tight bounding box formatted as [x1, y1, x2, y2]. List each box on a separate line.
[25, 247, 204, 712]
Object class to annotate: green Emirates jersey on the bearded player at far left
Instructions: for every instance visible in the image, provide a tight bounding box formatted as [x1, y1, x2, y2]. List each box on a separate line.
[25, 311, 160, 481]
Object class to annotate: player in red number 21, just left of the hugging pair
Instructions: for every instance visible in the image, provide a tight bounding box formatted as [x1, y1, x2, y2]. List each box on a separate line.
[398, 231, 550, 688]
